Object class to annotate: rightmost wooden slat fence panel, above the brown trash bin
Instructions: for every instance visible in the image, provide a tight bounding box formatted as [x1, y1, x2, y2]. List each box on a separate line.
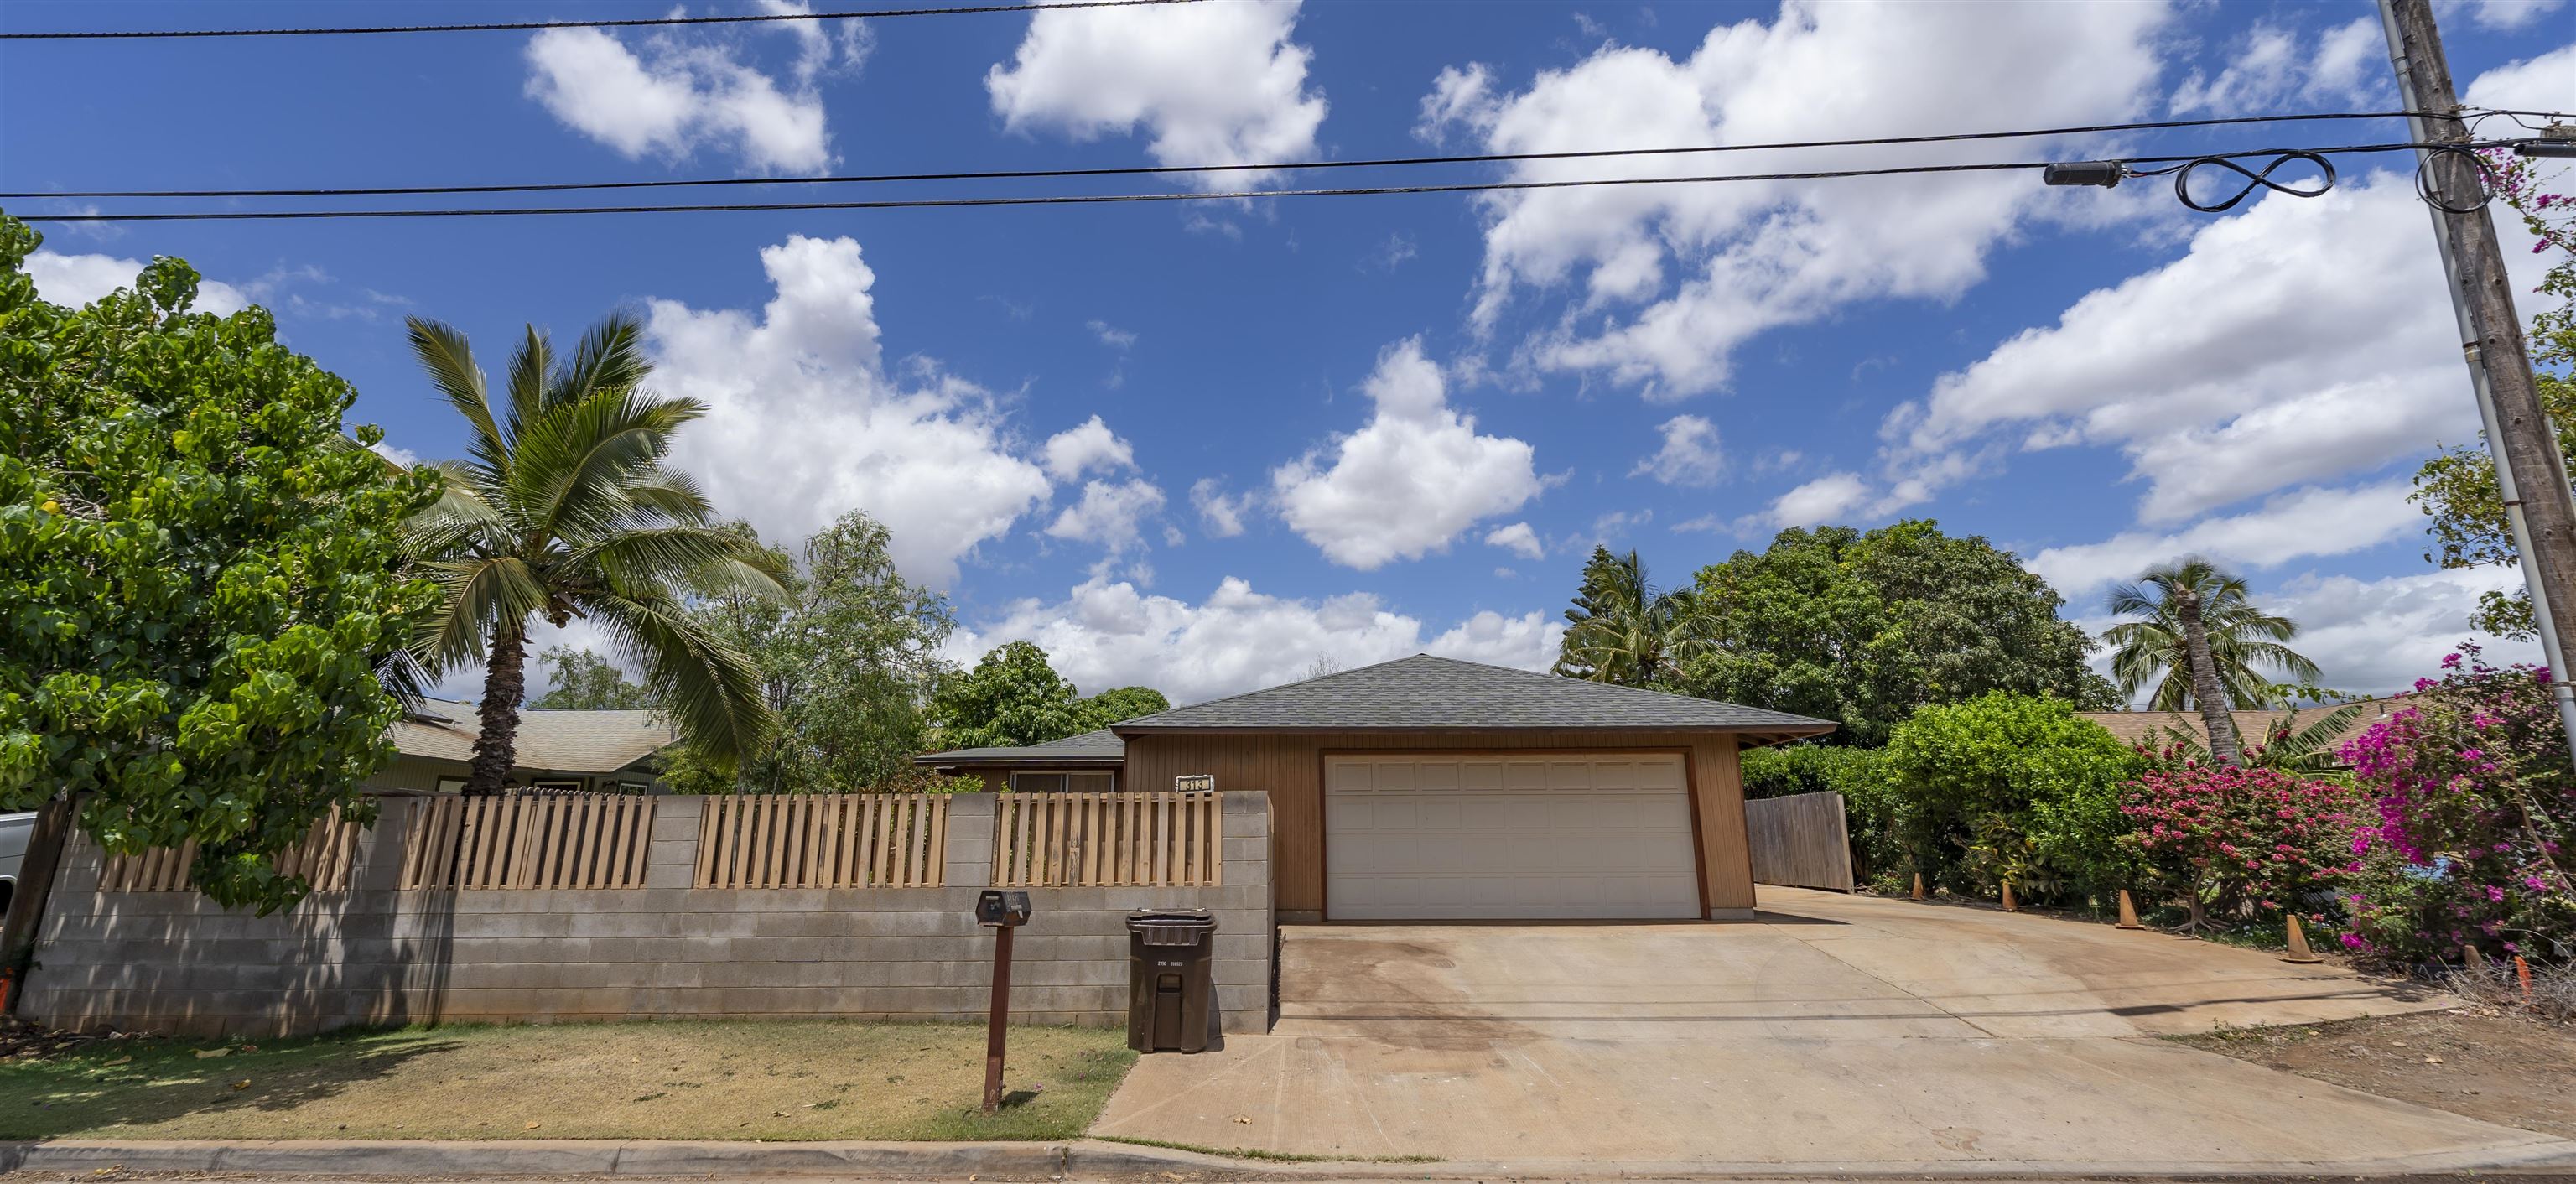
[992, 792, 1223, 888]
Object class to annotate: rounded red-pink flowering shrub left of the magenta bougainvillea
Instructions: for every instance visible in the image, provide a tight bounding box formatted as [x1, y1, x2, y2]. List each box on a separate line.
[2120, 762, 2352, 929]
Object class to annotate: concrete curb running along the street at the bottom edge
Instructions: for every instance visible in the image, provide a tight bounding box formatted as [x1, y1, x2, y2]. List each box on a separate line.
[0, 1138, 2576, 1181]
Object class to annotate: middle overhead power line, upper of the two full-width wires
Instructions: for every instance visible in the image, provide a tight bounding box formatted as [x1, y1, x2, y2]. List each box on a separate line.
[0, 111, 2411, 198]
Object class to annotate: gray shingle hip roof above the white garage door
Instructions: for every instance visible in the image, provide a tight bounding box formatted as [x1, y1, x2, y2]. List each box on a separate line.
[1110, 654, 1834, 736]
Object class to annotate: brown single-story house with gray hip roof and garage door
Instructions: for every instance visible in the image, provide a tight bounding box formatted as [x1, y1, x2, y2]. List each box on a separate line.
[917, 654, 1834, 922]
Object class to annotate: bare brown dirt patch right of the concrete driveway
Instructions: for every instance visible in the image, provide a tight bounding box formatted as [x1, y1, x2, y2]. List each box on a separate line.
[2169, 1009, 2576, 1138]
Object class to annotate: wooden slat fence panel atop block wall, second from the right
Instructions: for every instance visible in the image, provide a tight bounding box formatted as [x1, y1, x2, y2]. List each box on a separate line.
[699, 792, 948, 888]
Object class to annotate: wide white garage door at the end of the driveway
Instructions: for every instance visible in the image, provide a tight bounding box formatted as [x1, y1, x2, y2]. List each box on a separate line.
[1324, 754, 1701, 922]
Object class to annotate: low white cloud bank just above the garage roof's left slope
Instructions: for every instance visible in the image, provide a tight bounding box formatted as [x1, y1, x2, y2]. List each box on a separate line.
[948, 577, 1564, 703]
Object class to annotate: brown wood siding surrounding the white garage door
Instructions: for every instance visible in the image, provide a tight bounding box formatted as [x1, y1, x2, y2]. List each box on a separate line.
[1123, 729, 1754, 914]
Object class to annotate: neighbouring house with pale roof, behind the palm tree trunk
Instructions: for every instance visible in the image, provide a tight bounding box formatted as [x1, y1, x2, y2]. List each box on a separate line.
[366, 700, 680, 792]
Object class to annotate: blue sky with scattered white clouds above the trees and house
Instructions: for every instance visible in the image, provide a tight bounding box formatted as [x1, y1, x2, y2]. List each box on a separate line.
[0, 0, 2576, 700]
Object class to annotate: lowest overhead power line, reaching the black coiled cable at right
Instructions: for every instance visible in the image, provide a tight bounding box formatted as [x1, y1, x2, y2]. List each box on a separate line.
[5, 142, 2473, 221]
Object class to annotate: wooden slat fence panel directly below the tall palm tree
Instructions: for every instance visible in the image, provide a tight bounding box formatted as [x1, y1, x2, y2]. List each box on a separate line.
[402, 792, 654, 891]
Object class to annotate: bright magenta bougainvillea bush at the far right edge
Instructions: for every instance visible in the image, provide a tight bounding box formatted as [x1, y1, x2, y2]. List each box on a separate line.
[2345, 646, 2576, 963]
